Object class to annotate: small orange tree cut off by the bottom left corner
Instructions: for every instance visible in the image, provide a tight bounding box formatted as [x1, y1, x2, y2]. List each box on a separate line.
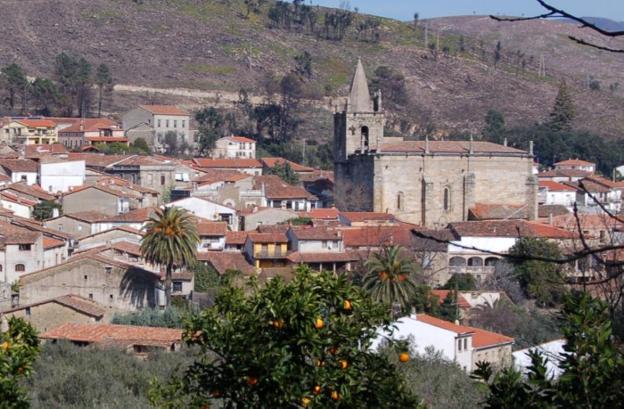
[0, 317, 39, 409]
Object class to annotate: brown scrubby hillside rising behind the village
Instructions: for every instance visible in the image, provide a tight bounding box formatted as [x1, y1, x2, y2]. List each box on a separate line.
[0, 0, 624, 138]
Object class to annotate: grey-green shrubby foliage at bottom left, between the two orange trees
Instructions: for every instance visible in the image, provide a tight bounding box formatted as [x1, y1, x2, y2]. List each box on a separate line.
[28, 343, 191, 409]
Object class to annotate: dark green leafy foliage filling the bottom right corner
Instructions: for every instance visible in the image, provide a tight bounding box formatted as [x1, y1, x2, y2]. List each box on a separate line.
[475, 294, 624, 409]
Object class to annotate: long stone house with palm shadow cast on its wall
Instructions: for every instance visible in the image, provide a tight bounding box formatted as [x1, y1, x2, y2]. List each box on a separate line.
[20, 252, 162, 311]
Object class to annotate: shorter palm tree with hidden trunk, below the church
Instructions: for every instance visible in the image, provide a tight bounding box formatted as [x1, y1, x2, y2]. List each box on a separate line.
[363, 246, 418, 310]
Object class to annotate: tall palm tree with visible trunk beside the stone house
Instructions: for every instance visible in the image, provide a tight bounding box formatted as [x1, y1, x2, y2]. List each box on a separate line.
[141, 207, 199, 307]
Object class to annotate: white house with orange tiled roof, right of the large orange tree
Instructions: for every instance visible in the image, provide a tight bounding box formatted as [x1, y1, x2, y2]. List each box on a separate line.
[373, 314, 513, 372]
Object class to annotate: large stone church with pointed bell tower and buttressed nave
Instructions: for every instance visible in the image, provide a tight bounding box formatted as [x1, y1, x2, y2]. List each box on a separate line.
[334, 61, 538, 228]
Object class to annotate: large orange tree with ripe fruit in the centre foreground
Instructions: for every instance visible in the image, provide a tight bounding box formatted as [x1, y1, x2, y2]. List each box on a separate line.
[151, 267, 420, 408]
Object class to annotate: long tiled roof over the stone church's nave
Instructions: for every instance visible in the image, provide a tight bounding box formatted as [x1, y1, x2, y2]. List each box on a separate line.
[381, 141, 528, 155]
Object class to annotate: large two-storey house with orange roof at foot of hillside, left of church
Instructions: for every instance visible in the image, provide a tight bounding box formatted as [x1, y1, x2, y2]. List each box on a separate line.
[122, 105, 194, 150]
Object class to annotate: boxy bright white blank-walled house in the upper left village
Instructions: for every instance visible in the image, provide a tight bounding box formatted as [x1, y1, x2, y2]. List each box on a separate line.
[39, 158, 86, 193]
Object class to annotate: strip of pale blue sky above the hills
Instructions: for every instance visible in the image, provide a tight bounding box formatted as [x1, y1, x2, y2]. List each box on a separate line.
[306, 0, 624, 21]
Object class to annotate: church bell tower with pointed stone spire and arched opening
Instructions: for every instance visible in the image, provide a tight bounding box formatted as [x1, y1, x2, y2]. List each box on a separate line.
[334, 58, 385, 163]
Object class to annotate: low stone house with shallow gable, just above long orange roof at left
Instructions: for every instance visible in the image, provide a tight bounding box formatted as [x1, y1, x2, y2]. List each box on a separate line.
[0, 294, 108, 333]
